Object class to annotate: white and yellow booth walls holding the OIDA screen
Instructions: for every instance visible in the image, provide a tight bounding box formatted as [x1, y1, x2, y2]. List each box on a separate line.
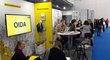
[0, 0, 53, 60]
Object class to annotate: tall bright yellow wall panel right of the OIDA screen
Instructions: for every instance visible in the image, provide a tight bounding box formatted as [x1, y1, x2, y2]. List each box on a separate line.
[35, 2, 53, 48]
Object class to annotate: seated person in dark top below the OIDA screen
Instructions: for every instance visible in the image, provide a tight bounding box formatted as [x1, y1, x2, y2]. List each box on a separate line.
[11, 40, 31, 60]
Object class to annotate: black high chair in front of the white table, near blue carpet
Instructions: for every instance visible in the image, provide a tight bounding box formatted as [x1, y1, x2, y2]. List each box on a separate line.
[72, 38, 88, 60]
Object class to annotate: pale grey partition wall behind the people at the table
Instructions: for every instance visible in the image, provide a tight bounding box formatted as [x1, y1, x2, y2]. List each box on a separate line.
[63, 9, 87, 23]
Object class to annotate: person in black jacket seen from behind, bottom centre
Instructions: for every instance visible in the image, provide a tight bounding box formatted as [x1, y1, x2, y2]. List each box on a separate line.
[48, 41, 66, 60]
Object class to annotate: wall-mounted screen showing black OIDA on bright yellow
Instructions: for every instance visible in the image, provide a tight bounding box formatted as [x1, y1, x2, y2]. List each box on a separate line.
[5, 14, 31, 36]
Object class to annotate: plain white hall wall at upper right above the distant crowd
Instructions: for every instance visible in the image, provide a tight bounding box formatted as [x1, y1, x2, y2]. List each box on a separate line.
[74, 0, 110, 25]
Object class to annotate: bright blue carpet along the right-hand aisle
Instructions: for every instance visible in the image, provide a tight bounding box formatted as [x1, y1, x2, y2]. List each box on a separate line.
[92, 28, 110, 60]
